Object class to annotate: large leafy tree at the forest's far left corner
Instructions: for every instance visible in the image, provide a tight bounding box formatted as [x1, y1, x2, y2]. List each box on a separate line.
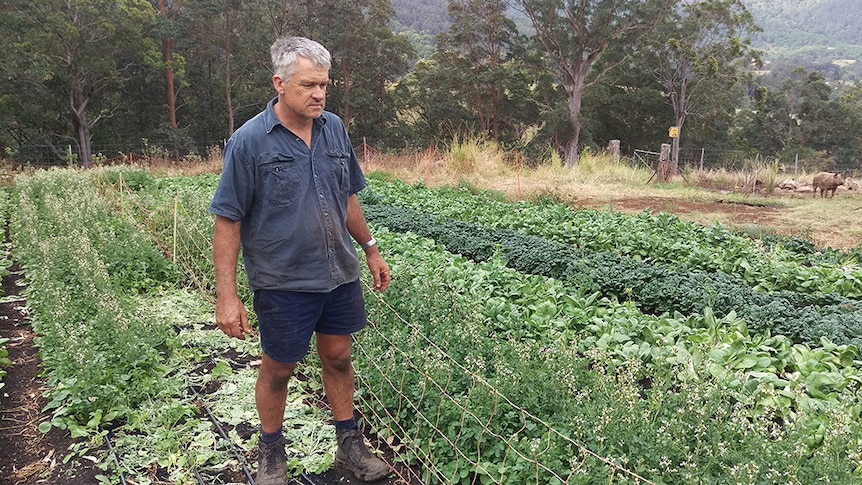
[2, 0, 158, 166]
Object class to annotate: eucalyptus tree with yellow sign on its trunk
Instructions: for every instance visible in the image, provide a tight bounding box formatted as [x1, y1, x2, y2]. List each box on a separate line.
[638, 0, 761, 172]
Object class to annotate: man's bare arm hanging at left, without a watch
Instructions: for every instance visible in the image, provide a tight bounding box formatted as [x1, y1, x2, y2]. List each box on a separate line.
[213, 216, 253, 340]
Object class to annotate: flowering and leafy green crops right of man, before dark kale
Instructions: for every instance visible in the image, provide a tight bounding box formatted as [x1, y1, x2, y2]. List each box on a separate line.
[357, 228, 862, 484]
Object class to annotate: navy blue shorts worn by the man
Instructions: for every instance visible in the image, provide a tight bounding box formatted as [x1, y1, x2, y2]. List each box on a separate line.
[254, 280, 368, 364]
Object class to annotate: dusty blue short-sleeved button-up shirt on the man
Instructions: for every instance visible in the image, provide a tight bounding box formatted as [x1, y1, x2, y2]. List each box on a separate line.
[209, 99, 372, 292]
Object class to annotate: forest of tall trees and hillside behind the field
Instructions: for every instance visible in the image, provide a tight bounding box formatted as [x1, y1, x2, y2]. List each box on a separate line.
[0, 0, 862, 170]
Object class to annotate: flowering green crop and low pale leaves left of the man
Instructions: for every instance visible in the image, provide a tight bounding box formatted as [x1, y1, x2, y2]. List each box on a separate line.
[11, 170, 334, 484]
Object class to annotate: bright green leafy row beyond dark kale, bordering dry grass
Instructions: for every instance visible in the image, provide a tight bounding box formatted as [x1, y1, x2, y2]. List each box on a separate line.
[360, 177, 862, 298]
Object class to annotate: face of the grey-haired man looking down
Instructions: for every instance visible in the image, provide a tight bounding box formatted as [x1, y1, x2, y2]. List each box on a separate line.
[273, 57, 329, 122]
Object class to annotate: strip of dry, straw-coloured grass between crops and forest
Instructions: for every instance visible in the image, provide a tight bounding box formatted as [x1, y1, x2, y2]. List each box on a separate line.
[359, 141, 862, 249]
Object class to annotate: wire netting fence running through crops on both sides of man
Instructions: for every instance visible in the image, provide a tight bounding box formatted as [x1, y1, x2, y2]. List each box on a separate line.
[114, 178, 652, 485]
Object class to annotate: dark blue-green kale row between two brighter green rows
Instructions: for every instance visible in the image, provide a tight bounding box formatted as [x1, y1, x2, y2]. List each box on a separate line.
[364, 205, 862, 347]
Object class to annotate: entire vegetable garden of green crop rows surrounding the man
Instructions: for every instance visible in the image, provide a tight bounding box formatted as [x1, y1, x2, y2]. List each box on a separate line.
[1, 169, 862, 484]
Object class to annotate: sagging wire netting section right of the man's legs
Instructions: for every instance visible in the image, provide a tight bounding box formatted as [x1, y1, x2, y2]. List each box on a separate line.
[357, 285, 653, 485]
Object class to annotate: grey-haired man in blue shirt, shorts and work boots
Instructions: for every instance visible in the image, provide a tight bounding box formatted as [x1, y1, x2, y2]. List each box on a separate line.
[209, 37, 390, 485]
